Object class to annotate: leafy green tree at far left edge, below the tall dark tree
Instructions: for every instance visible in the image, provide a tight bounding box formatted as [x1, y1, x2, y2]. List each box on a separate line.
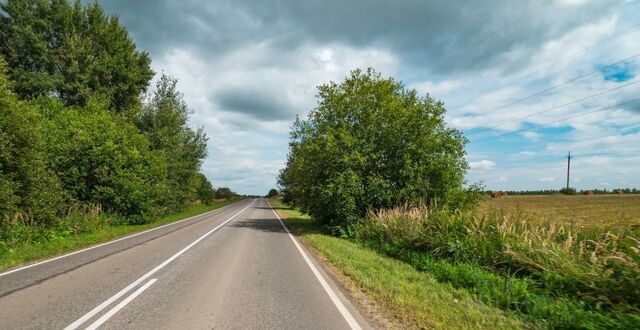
[0, 57, 65, 224]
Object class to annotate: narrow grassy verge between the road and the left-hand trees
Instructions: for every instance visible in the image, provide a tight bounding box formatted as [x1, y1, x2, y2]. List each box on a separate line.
[0, 198, 240, 271]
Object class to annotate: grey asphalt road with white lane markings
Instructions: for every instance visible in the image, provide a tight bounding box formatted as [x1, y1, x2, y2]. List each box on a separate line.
[0, 199, 369, 329]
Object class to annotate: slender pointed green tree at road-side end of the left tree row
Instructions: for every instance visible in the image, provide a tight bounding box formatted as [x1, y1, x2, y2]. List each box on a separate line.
[137, 74, 207, 210]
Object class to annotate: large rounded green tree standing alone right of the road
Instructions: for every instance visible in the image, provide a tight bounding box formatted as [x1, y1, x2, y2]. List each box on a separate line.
[278, 69, 478, 225]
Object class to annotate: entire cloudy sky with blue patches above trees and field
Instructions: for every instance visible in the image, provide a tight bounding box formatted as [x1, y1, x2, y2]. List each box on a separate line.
[101, 0, 640, 194]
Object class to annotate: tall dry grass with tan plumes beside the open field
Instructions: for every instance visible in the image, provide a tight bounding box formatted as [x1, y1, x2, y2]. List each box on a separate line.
[356, 207, 640, 312]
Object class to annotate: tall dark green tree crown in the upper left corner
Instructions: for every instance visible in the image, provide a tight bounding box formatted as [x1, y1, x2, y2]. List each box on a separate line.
[0, 0, 153, 112]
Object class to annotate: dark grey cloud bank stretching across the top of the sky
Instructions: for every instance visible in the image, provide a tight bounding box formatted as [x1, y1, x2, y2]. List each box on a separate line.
[104, 0, 623, 73]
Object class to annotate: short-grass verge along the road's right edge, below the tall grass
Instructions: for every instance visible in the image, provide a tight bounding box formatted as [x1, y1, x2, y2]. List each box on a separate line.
[271, 199, 528, 329]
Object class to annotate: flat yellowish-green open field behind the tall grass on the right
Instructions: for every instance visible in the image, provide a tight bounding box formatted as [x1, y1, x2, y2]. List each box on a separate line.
[479, 195, 640, 228]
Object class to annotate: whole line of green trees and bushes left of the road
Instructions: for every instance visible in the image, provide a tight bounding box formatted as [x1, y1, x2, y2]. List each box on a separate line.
[0, 0, 230, 226]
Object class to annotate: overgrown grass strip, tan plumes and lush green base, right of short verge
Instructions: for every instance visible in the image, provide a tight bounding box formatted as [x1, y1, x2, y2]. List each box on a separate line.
[354, 207, 640, 329]
